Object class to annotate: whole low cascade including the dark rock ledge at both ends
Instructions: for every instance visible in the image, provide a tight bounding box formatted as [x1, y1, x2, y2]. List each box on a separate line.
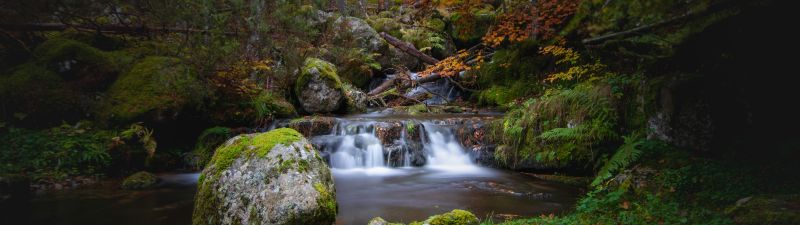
[270, 114, 500, 169]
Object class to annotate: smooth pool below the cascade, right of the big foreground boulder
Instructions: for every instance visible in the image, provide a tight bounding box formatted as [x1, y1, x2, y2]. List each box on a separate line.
[333, 165, 577, 224]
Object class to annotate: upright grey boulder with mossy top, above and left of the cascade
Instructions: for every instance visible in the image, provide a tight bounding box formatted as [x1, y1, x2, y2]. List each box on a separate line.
[295, 58, 344, 113]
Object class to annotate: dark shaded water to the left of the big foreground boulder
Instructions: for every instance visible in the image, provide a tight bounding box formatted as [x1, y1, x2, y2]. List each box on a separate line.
[0, 173, 199, 225]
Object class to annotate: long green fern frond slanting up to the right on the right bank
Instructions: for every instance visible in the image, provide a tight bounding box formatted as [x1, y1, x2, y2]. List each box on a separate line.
[592, 134, 644, 186]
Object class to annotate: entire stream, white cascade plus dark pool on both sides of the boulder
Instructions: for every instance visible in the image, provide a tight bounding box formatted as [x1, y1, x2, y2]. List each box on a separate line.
[6, 114, 578, 225]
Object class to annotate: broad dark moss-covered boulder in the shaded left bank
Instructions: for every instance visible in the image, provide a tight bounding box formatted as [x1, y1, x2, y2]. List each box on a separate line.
[98, 56, 208, 122]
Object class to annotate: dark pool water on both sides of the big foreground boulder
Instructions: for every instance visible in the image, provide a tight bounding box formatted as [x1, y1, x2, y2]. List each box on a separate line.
[0, 169, 576, 225]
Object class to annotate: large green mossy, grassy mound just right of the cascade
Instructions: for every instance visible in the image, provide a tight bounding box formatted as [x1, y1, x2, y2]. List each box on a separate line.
[492, 82, 620, 167]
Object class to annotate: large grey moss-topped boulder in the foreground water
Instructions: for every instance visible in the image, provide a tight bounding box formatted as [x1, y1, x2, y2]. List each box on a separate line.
[192, 128, 337, 225]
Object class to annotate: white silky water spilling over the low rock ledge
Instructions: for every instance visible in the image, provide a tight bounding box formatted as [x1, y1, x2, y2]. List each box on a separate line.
[312, 119, 472, 169]
